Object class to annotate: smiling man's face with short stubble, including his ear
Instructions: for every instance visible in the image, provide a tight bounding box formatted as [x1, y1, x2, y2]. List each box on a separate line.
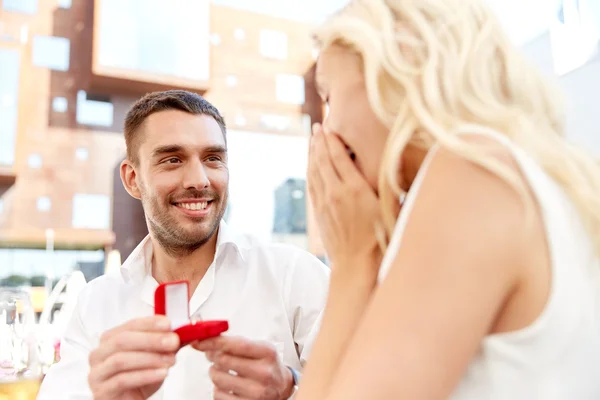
[122, 110, 229, 253]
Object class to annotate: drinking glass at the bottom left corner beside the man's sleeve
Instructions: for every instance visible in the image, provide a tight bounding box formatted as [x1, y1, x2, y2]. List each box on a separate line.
[0, 287, 42, 400]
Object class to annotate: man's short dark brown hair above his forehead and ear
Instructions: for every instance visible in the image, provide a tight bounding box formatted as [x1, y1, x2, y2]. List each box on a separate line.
[124, 90, 227, 164]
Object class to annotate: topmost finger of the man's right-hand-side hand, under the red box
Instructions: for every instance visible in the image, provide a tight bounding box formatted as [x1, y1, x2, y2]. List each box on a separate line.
[192, 336, 277, 360]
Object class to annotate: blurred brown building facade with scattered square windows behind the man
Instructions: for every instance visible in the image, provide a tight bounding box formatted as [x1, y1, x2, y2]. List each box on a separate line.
[0, 0, 323, 288]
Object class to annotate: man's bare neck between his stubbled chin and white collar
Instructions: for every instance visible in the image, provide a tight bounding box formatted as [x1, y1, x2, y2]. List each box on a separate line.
[152, 231, 218, 296]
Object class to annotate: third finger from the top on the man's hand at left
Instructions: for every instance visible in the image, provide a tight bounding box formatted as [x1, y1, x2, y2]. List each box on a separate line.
[89, 351, 175, 385]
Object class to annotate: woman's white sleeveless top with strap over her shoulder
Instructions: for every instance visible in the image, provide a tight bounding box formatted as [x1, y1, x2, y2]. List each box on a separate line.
[379, 131, 600, 400]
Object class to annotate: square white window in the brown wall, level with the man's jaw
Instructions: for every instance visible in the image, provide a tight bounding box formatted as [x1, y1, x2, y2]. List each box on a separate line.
[72, 194, 110, 229]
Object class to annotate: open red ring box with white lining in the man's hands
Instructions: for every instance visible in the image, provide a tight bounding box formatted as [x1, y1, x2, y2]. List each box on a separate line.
[154, 281, 229, 347]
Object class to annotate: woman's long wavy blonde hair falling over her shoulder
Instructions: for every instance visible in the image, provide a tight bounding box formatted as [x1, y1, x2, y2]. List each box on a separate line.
[315, 0, 600, 253]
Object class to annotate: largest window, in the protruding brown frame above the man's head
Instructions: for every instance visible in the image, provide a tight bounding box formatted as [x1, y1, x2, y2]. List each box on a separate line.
[98, 0, 210, 81]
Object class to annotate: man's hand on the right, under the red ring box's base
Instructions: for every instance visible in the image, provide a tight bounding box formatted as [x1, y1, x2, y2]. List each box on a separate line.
[192, 336, 294, 400]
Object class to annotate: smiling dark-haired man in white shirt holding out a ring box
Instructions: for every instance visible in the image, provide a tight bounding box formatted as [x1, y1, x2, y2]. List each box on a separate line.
[38, 91, 328, 400]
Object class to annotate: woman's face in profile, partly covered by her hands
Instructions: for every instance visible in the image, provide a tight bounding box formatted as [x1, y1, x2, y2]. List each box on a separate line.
[317, 45, 389, 191]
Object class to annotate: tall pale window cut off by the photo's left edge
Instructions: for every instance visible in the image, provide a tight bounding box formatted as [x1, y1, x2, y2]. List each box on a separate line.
[0, 49, 21, 165]
